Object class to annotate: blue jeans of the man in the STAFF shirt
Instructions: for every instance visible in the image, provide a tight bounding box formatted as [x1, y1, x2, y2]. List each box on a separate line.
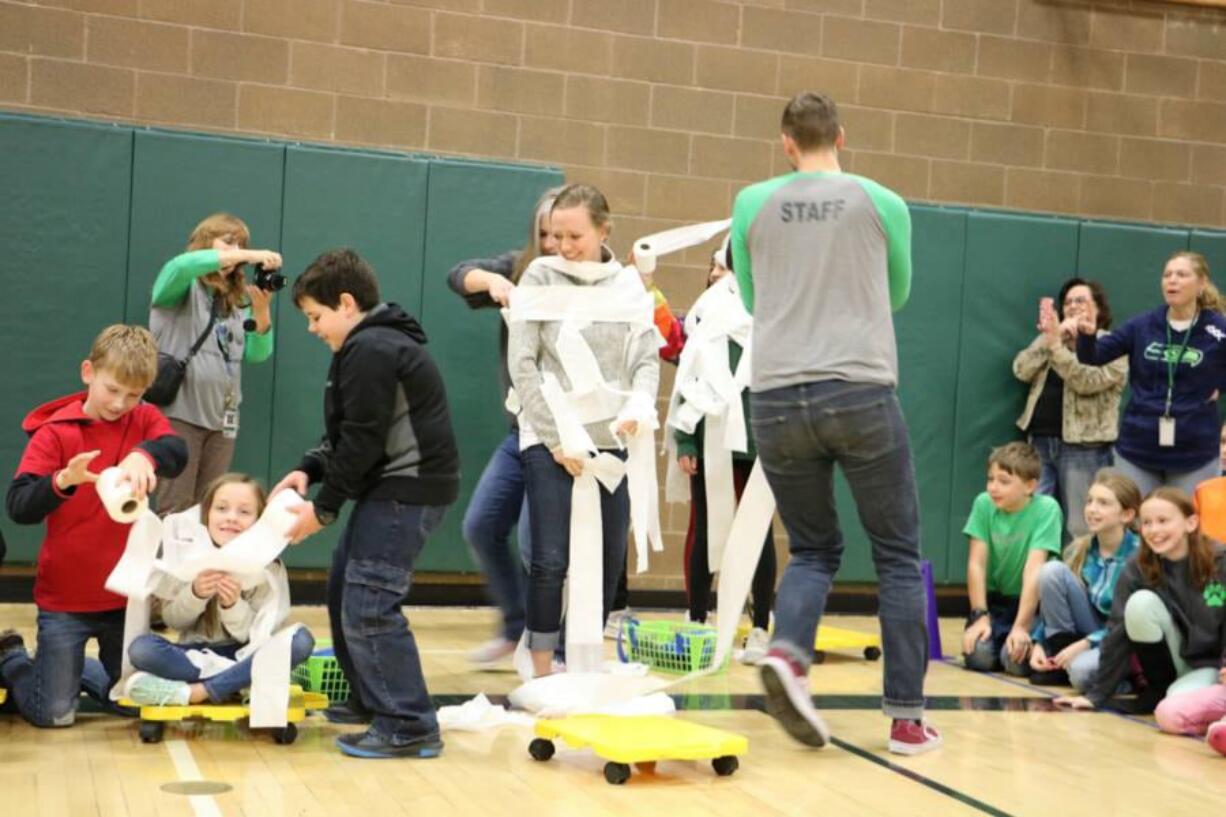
[750, 380, 928, 719]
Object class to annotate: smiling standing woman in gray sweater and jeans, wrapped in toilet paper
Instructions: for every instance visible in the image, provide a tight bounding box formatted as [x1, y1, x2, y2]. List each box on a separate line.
[508, 184, 660, 675]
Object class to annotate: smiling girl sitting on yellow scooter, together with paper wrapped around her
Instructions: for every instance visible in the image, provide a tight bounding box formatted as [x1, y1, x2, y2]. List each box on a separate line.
[113, 474, 314, 725]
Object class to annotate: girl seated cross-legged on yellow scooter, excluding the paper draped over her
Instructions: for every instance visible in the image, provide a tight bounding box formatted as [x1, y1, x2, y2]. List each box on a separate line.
[124, 474, 315, 707]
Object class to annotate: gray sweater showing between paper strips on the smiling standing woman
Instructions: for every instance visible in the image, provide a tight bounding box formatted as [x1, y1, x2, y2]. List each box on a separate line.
[506, 256, 660, 449]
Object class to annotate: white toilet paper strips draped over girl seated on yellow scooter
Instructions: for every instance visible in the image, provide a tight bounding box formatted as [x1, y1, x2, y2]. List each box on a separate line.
[107, 491, 303, 729]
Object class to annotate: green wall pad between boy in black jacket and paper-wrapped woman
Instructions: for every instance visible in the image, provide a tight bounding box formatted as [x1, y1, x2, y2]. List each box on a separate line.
[421, 161, 562, 570]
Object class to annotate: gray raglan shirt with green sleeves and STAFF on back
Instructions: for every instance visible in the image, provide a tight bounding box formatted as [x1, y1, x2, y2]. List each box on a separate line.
[732, 172, 911, 391]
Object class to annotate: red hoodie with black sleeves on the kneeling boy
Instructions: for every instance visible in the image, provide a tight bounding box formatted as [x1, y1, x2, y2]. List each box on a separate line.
[9, 391, 178, 612]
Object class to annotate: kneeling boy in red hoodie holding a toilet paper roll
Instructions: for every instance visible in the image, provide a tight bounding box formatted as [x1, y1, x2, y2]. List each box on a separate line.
[0, 324, 188, 726]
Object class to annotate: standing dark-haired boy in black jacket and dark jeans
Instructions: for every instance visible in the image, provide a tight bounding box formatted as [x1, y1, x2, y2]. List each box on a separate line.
[272, 249, 460, 758]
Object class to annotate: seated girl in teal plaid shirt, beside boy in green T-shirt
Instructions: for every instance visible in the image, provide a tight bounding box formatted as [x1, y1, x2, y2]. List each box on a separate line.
[1030, 469, 1141, 691]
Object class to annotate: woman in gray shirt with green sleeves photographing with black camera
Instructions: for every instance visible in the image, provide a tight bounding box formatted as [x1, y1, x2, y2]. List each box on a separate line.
[146, 213, 284, 515]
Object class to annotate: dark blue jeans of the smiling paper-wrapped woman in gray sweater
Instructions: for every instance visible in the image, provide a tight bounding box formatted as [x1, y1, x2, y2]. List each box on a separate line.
[524, 445, 630, 650]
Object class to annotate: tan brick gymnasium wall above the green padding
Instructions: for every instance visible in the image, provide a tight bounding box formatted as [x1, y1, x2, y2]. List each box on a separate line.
[0, 0, 1226, 586]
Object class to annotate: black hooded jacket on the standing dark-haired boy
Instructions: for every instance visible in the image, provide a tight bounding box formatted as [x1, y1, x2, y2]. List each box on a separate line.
[298, 303, 460, 513]
